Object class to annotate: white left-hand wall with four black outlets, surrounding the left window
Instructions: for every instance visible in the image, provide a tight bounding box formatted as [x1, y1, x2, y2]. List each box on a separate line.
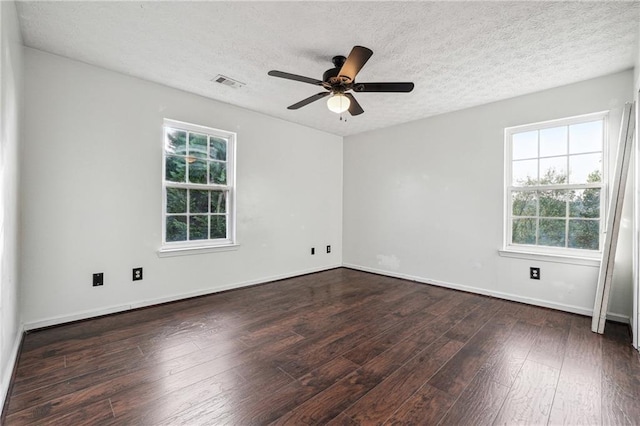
[22, 49, 342, 328]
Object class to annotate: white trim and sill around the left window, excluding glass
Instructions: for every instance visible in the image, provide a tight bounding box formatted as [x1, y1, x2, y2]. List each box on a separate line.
[157, 118, 239, 257]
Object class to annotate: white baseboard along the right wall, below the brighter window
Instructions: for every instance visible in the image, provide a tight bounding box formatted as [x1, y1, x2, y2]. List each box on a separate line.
[342, 263, 631, 324]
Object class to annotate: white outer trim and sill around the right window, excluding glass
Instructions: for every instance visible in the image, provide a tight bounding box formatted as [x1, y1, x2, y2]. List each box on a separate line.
[498, 111, 609, 266]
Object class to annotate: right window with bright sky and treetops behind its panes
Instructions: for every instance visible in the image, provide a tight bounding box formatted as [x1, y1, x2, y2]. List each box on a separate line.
[505, 113, 607, 256]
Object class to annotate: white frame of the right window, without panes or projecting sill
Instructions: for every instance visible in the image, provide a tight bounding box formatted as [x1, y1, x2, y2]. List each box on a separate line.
[502, 111, 610, 259]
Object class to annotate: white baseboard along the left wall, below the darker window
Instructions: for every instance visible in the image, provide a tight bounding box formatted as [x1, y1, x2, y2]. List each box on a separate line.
[24, 264, 342, 330]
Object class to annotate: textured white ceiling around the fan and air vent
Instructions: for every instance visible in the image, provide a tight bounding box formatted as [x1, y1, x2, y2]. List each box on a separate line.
[18, 1, 639, 135]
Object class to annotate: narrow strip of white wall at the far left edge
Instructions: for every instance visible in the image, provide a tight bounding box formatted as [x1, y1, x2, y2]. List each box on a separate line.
[0, 1, 23, 410]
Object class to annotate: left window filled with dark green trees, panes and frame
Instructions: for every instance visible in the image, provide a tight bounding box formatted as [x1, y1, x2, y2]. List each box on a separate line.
[162, 120, 236, 250]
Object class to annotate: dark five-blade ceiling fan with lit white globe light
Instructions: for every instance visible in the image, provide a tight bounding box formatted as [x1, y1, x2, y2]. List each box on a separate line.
[268, 46, 413, 115]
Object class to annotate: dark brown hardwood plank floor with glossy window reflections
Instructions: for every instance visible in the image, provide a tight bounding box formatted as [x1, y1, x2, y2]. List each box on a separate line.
[4, 269, 640, 425]
